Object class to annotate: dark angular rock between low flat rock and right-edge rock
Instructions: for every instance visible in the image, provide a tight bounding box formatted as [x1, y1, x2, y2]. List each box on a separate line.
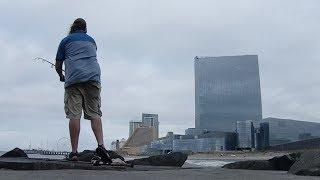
[269, 153, 301, 171]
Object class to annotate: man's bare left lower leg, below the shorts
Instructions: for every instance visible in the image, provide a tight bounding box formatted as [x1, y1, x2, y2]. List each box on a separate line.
[69, 119, 80, 153]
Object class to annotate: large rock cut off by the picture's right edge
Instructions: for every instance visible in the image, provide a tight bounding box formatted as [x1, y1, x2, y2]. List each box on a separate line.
[288, 151, 320, 175]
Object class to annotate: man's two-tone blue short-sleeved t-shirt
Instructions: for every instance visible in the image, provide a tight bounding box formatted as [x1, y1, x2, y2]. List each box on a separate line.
[56, 31, 101, 87]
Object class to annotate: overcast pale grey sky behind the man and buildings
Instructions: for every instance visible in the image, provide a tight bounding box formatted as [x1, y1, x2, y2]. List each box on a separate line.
[0, 0, 320, 151]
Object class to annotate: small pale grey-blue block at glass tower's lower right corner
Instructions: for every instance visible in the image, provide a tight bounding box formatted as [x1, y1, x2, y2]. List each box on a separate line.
[236, 120, 255, 149]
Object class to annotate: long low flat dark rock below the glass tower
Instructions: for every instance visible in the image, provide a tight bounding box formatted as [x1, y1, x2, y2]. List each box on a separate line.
[222, 160, 274, 170]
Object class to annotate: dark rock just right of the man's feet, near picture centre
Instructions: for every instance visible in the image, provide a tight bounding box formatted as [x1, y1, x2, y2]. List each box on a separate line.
[127, 152, 188, 167]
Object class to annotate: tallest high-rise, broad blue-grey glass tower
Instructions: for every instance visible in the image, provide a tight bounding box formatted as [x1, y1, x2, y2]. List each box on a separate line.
[194, 55, 262, 132]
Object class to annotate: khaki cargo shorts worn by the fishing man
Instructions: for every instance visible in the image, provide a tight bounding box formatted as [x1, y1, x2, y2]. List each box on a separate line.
[64, 81, 102, 120]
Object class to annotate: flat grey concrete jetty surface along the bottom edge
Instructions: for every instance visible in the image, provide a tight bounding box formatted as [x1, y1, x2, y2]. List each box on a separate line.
[0, 167, 319, 180]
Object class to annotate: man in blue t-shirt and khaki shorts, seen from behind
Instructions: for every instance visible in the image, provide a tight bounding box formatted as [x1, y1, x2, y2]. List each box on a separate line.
[55, 18, 112, 164]
